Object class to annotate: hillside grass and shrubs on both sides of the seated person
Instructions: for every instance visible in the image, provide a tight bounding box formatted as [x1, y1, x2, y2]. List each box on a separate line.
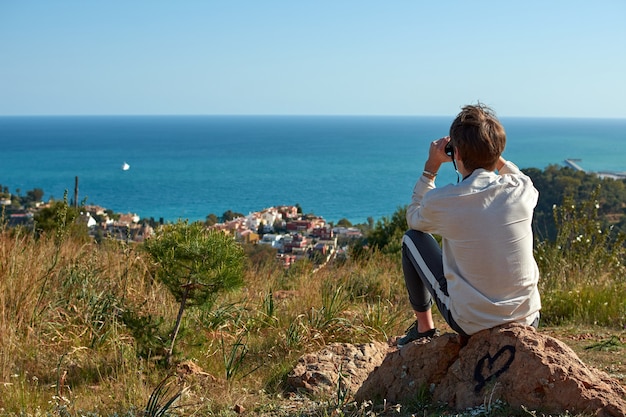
[0, 166, 626, 417]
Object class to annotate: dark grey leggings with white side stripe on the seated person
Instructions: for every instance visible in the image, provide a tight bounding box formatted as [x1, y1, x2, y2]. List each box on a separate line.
[402, 230, 539, 337]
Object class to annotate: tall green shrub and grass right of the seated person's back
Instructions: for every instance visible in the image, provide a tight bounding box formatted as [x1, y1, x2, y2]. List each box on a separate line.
[535, 187, 626, 326]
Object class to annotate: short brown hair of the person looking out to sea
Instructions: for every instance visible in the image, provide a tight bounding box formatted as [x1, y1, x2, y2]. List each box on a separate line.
[450, 103, 506, 171]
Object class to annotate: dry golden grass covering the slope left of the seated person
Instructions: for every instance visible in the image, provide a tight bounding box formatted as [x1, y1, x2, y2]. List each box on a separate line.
[0, 223, 623, 416]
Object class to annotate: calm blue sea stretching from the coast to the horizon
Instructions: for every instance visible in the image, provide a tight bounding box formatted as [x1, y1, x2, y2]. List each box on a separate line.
[0, 116, 626, 223]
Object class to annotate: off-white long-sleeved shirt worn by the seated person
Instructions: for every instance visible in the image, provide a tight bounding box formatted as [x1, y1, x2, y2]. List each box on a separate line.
[407, 161, 541, 335]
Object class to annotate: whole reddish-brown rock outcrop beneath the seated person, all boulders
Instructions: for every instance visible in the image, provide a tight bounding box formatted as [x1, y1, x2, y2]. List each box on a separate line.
[289, 324, 626, 417]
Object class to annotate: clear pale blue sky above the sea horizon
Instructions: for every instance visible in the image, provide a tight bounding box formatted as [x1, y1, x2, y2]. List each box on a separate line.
[0, 0, 626, 118]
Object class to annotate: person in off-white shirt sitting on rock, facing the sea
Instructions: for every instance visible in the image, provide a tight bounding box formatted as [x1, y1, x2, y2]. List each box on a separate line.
[398, 104, 541, 347]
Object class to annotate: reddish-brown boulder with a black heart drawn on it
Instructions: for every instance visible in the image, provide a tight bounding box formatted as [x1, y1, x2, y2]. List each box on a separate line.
[434, 325, 626, 416]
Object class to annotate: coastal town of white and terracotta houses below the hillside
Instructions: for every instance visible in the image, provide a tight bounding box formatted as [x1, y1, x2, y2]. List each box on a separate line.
[0, 193, 363, 268]
